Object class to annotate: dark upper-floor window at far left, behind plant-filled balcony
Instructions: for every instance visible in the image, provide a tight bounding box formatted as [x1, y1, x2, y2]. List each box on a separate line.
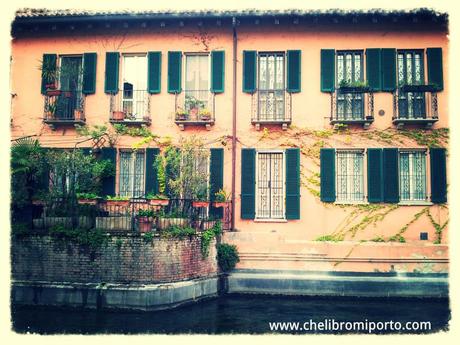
[54, 55, 83, 120]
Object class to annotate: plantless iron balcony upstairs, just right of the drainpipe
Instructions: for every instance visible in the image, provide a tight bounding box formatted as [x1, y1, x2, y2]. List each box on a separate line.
[251, 90, 292, 130]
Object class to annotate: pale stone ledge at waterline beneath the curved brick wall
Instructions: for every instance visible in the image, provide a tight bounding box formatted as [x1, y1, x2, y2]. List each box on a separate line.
[11, 277, 218, 311]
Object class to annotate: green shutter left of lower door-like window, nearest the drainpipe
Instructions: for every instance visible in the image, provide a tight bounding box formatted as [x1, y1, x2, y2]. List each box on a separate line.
[241, 149, 256, 219]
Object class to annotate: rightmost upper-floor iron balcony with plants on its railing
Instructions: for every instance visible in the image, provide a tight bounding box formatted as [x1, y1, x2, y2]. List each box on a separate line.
[393, 85, 438, 129]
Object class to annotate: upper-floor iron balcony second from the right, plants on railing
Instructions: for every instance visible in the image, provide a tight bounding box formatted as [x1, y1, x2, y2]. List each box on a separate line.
[330, 87, 374, 129]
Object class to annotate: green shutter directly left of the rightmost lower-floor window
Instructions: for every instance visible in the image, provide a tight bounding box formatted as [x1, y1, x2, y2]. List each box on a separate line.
[383, 148, 399, 203]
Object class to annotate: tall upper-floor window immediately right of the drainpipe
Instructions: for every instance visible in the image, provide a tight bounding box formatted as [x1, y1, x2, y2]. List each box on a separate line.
[258, 53, 285, 121]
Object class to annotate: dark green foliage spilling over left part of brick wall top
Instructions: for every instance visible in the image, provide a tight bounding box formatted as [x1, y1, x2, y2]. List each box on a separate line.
[49, 224, 108, 249]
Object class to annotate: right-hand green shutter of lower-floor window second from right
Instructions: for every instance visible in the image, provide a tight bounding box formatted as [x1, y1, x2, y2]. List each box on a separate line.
[367, 149, 383, 202]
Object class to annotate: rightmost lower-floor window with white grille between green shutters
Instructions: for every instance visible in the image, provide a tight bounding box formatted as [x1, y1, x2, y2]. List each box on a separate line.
[399, 151, 427, 201]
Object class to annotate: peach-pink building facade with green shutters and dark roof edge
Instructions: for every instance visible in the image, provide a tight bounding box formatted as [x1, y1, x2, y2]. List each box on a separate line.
[11, 11, 449, 272]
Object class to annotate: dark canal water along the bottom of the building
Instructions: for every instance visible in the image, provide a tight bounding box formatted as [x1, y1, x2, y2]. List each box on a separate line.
[12, 295, 450, 334]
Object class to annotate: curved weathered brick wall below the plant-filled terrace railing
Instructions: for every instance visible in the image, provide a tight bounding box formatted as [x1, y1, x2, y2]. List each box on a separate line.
[11, 235, 217, 283]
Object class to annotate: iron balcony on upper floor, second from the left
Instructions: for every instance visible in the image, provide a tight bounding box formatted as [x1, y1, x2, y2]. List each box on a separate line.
[109, 90, 151, 125]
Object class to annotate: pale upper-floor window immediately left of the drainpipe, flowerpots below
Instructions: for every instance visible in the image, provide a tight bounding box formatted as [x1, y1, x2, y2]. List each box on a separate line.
[184, 54, 210, 113]
